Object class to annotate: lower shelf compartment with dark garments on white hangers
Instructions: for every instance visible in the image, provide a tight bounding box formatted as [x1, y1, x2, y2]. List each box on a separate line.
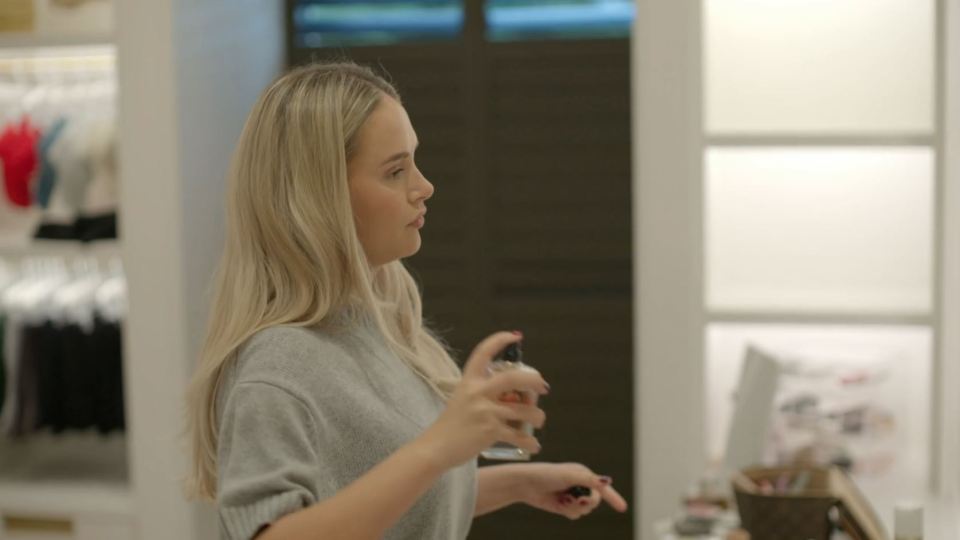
[0, 256, 126, 440]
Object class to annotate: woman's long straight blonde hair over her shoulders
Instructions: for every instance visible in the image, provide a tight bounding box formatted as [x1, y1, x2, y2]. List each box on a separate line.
[187, 63, 460, 499]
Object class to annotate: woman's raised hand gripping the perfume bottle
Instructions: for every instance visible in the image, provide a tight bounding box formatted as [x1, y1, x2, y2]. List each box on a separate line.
[420, 332, 548, 469]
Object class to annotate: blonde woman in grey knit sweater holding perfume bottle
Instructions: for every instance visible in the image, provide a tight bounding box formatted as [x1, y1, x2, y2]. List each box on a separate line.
[189, 63, 626, 540]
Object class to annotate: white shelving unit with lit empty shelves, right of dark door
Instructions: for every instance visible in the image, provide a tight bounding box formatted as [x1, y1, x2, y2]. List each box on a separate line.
[634, 0, 960, 538]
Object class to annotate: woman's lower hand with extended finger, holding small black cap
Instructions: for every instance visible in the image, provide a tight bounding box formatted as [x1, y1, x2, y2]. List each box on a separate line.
[516, 463, 627, 519]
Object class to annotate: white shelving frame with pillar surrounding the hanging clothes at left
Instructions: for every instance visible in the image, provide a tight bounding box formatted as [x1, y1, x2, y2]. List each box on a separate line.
[0, 0, 285, 540]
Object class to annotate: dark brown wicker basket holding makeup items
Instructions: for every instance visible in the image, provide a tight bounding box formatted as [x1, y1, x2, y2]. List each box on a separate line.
[733, 467, 839, 540]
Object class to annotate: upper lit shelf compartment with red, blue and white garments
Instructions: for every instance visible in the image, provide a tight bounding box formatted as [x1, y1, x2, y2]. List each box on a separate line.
[0, 47, 119, 243]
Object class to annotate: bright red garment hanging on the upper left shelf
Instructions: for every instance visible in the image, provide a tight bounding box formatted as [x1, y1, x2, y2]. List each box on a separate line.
[0, 118, 40, 207]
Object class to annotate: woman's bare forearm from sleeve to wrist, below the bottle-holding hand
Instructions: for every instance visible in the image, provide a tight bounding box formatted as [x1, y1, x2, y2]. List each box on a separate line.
[257, 439, 444, 540]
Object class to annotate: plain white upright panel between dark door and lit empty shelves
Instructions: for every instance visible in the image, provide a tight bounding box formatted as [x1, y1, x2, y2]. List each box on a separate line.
[632, 0, 705, 538]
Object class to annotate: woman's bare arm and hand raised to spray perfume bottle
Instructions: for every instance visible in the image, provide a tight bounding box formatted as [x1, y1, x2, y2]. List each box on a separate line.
[257, 332, 547, 540]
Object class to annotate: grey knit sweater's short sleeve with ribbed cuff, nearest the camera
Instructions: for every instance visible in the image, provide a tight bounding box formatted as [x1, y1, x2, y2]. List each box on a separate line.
[217, 382, 330, 540]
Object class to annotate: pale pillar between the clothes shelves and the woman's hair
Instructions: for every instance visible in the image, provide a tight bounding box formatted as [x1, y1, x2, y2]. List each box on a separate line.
[116, 0, 285, 540]
